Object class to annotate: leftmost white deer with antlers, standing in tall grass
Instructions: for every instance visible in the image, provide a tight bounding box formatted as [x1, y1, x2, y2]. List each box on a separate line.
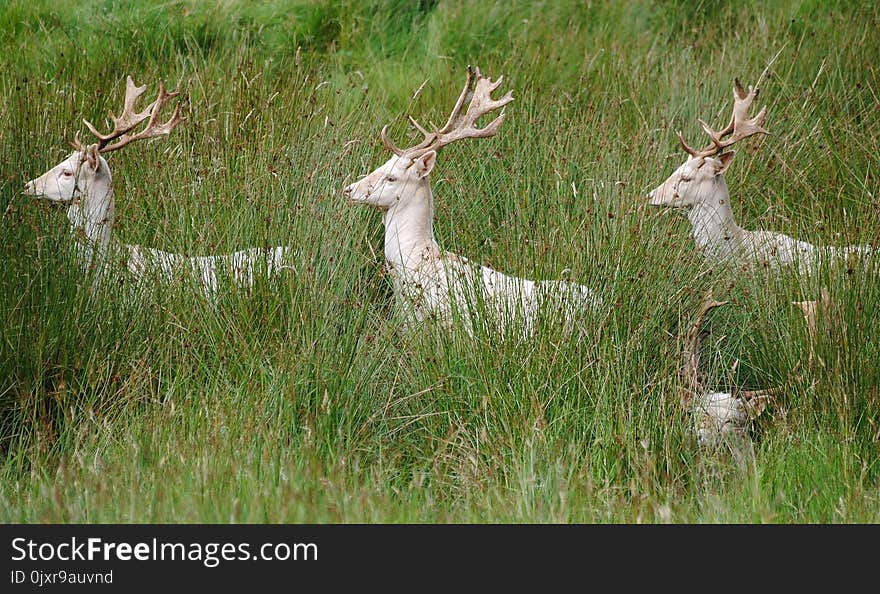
[25, 76, 290, 296]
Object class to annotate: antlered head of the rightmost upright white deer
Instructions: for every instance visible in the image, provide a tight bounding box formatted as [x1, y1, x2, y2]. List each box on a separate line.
[648, 80, 768, 207]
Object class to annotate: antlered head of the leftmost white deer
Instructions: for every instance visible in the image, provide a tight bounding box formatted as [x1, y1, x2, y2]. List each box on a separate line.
[24, 76, 183, 203]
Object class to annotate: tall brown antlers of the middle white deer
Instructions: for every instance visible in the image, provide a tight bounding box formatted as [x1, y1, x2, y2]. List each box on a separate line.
[380, 66, 513, 156]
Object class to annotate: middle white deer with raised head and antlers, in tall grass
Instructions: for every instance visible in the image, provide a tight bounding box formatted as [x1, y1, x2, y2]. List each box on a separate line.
[343, 66, 601, 336]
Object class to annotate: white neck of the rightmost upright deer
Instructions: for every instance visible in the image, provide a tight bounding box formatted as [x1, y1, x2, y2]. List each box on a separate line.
[688, 175, 743, 257]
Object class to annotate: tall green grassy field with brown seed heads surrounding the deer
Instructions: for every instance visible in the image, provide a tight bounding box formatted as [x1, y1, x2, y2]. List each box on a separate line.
[0, 0, 880, 522]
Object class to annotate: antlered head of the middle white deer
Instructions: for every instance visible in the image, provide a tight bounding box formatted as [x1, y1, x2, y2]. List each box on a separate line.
[343, 66, 513, 211]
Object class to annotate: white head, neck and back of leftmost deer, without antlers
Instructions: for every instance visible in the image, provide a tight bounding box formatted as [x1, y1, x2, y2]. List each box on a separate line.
[25, 148, 293, 297]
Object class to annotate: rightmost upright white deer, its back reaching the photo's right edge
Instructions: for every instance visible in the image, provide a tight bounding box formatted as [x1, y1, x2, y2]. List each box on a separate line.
[648, 80, 873, 273]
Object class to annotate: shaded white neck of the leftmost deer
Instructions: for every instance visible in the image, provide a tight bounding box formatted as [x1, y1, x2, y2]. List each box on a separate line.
[67, 175, 115, 269]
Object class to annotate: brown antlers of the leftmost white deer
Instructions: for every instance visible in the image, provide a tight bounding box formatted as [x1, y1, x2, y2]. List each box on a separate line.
[81, 76, 186, 153]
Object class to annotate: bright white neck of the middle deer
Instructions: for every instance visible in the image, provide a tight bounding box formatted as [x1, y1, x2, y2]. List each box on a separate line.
[383, 178, 440, 270]
